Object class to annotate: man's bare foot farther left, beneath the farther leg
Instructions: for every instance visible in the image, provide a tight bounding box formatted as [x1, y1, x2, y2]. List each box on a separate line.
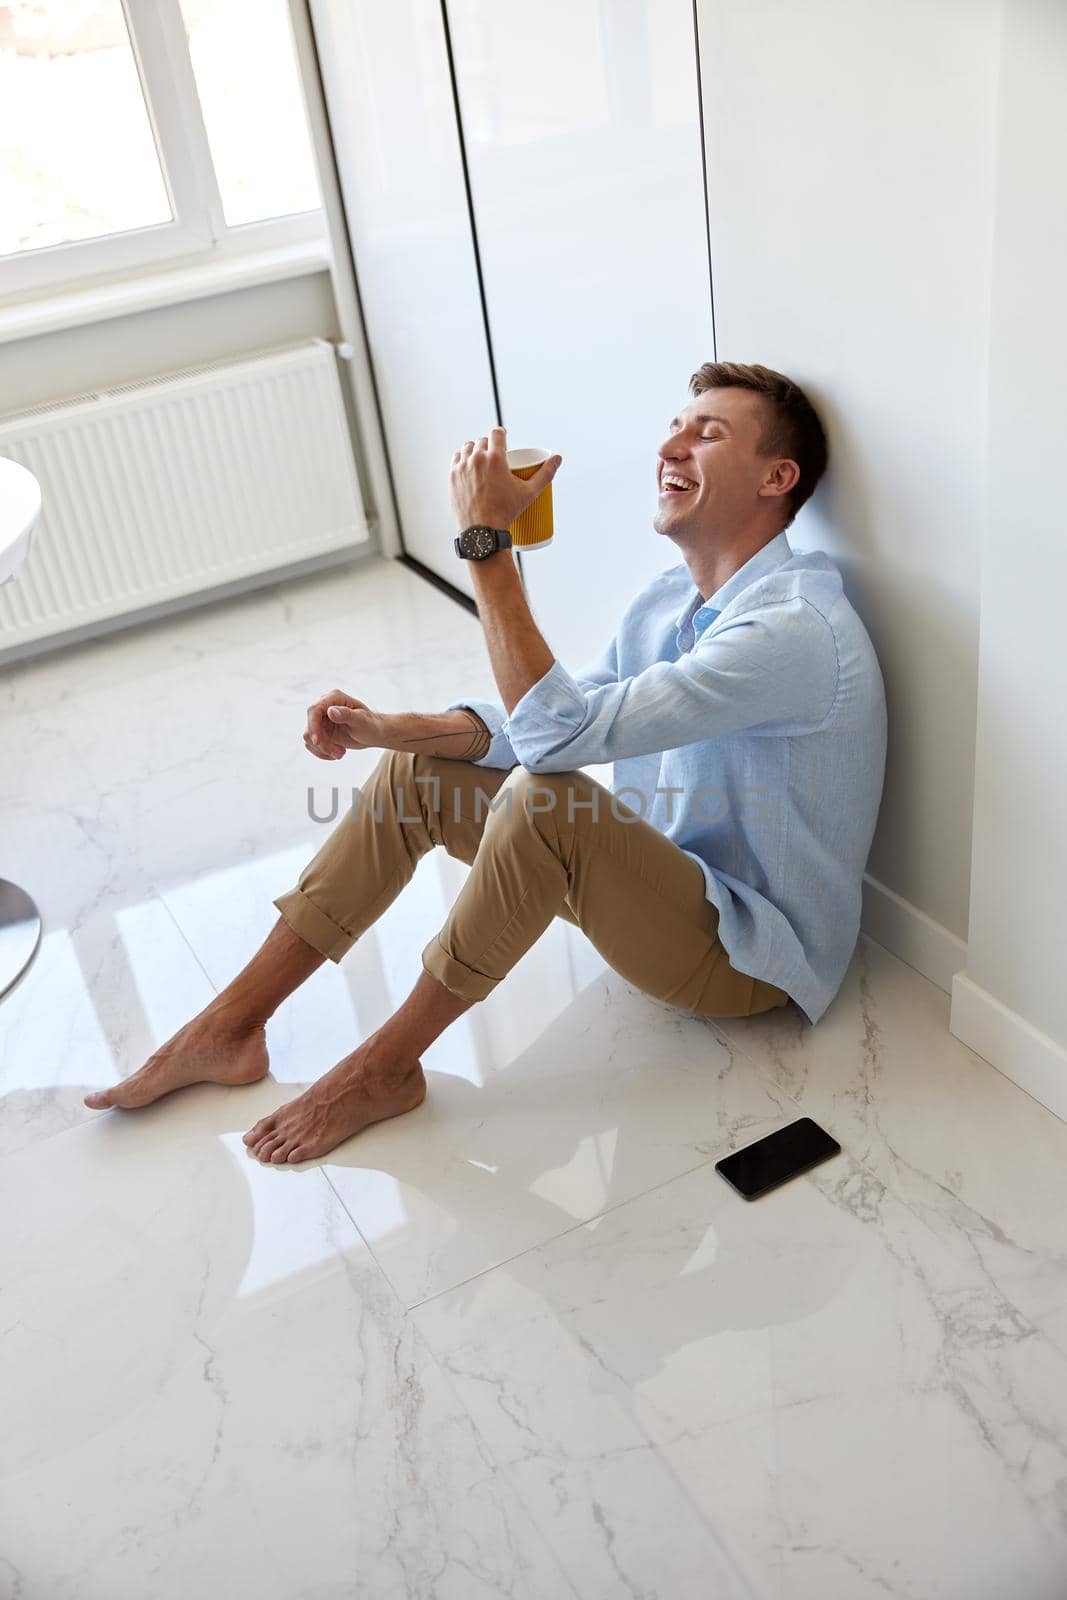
[85, 1005, 270, 1110]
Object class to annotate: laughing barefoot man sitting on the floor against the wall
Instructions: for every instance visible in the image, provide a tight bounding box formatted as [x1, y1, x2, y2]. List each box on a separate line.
[85, 362, 886, 1163]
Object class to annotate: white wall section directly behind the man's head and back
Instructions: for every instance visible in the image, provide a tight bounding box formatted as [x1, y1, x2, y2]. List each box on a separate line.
[697, 0, 1000, 987]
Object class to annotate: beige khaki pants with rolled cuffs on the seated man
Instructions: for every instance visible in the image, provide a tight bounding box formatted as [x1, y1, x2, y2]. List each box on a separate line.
[274, 750, 789, 1016]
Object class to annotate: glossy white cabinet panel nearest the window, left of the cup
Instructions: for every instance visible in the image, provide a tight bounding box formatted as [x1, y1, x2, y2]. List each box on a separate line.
[310, 0, 498, 598]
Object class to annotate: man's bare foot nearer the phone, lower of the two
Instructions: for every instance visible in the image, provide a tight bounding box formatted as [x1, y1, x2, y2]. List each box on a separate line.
[245, 1042, 426, 1166]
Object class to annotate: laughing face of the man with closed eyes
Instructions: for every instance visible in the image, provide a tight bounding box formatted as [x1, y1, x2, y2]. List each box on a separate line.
[653, 389, 798, 536]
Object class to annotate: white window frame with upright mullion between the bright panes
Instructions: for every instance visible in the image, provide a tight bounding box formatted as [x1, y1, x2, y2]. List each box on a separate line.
[0, 0, 326, 309]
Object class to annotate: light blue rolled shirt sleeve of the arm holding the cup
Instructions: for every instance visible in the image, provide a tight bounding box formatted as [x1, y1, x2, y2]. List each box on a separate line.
[501, 597, 840, 773]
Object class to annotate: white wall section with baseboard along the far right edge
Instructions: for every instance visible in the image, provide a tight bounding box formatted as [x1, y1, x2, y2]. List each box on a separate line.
[952, 0, 1067, 1117]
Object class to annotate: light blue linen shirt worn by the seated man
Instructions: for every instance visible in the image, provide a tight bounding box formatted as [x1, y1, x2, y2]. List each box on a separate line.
[448, 533, 886, 1022]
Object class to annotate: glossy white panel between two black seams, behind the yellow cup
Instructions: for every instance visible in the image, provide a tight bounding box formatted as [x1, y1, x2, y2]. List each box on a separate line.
[448, 0, 713, 670]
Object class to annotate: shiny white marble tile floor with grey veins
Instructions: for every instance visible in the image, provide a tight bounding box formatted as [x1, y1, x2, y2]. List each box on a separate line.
[0, 557, 1067, 1600]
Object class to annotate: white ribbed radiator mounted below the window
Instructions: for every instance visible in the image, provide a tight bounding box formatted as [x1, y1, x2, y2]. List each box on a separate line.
[0, 339, 370, 653]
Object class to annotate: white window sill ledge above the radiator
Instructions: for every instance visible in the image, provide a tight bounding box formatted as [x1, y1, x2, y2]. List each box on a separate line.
[0, 240, 330, 344]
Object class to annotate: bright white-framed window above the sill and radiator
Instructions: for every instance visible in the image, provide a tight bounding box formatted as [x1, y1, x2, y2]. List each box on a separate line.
[0, 0, 325, 306]
